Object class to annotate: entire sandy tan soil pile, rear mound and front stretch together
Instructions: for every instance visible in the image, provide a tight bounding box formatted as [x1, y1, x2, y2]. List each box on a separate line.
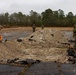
[0, 29, 68, 63]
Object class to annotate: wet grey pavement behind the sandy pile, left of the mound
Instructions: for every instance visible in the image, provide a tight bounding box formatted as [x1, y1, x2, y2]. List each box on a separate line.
[2, 31, 32, 41]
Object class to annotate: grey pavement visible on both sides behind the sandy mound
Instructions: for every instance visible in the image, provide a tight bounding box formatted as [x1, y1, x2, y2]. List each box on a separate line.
[2, 31, 74, 40]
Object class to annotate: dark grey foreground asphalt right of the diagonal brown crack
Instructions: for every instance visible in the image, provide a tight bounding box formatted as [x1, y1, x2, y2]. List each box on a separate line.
[25, 62, 76, 75]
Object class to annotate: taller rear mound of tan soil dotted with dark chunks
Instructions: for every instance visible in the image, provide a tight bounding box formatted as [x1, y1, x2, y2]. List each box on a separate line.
[23, 29, 68, 47]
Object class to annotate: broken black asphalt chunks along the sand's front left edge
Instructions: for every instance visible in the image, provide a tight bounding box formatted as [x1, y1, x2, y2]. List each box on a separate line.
[0, 58, 41, 66]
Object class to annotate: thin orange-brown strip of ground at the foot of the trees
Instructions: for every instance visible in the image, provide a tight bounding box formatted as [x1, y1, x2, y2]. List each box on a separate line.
[1, 27, 73, 32]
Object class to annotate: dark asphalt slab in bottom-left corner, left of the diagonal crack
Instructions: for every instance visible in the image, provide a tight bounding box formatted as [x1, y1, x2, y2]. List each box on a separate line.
[0, 65, 23, 75]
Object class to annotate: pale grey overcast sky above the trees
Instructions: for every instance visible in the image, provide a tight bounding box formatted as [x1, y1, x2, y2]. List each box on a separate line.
[0, 0, 76, 14]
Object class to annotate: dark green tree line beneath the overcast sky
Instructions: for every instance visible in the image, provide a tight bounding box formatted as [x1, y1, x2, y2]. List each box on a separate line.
[0, 9, 76, 27]
